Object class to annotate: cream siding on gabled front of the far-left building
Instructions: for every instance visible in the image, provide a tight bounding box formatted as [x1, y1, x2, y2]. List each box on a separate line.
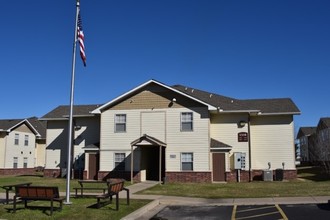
[5, 124, 36, 168]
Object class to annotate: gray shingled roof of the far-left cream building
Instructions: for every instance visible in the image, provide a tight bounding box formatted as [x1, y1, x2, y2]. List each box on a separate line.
[0, 117, 46, 139]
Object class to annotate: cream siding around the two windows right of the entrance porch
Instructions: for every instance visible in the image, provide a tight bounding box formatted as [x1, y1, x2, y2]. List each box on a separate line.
[166, 108, 210, 172]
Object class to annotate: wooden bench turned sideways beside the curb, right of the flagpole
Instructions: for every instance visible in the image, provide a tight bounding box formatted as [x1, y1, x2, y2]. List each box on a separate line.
[96, 180, 129, 210]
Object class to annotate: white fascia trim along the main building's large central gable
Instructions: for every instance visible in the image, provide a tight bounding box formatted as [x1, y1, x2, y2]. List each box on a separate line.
[91, 80, 217, 114]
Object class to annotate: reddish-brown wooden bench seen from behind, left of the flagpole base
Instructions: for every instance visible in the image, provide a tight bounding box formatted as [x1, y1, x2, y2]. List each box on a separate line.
[13, 186, 64, 215]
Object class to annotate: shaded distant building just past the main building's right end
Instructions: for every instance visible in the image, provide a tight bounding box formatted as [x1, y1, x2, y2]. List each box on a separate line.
[297, 127, 316, 164]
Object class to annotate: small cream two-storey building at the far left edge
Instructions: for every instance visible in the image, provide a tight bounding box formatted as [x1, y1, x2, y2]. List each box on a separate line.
[0, 117, 46, 174]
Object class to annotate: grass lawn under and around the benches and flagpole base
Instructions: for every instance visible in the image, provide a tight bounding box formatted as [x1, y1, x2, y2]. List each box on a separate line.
[0, 175, 147, 220]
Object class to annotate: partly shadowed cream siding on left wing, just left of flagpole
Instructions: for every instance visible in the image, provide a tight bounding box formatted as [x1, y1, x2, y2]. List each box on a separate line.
[46, 121, 68, 169]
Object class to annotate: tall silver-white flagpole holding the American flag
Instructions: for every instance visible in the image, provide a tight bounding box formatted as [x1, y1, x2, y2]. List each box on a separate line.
[64, 0, 80, 205]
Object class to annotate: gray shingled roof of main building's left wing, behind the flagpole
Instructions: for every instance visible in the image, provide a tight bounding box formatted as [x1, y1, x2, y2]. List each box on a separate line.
[41, 104, 101, 120]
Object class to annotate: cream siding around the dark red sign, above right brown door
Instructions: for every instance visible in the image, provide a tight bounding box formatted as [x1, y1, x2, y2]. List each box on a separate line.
[210, 114, 249, 171]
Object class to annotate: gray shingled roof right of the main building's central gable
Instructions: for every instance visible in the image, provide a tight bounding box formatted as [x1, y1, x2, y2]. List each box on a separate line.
[172, 85, 300, 114]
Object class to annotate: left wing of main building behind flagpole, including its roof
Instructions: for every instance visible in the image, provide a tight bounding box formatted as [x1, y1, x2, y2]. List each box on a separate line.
[40, 105, 100, 179]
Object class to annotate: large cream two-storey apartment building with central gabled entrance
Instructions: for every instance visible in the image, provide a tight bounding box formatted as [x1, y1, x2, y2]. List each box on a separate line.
[42, 80, 300, 182]
